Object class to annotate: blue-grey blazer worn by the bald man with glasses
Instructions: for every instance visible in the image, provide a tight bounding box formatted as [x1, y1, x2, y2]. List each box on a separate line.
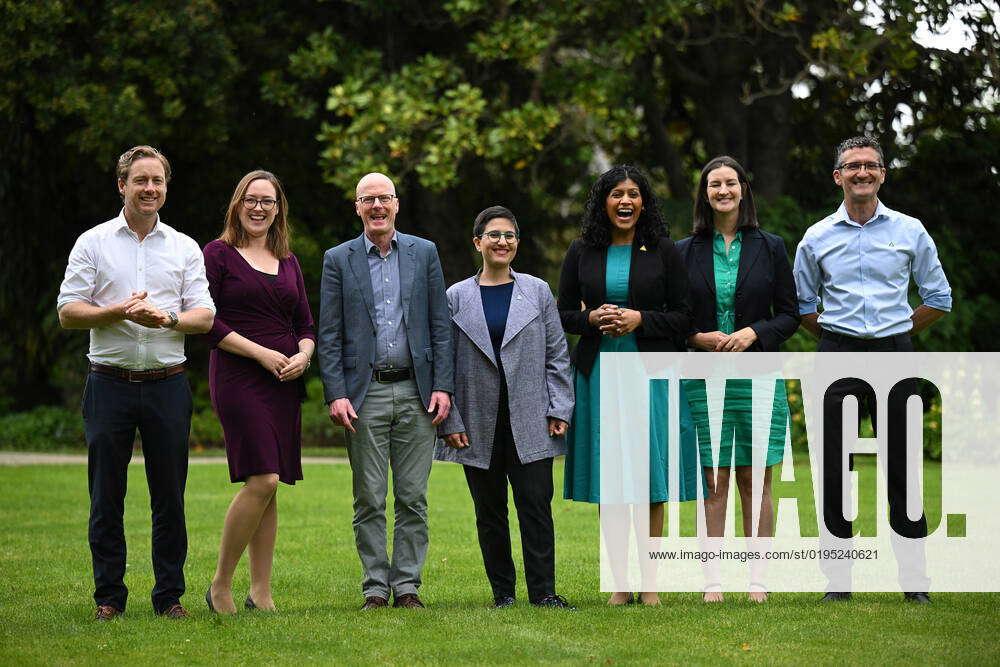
[316, 231, 454, 410]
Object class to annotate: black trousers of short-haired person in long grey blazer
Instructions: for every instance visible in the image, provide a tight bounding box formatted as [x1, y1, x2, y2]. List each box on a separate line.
[464, 410, 556, 602]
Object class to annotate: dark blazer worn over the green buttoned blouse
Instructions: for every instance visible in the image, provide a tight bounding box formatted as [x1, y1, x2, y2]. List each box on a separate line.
[677, 229, 801, 352]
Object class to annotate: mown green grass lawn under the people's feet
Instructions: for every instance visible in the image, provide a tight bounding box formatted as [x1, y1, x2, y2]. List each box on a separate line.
[0, 464, 1000, 664]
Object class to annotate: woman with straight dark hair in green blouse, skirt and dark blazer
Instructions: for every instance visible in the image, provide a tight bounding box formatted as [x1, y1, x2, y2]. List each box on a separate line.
[677, 156, 799, 602]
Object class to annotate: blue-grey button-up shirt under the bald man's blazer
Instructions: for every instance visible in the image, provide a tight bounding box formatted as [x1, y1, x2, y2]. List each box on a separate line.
[365, 232, 413, 369]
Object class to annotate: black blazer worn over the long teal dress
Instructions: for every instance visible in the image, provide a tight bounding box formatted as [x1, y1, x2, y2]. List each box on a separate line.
[556, 236, 691, 375]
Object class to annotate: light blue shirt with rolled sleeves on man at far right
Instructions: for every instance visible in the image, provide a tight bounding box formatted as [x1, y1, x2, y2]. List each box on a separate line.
[793, 201, 951, 338]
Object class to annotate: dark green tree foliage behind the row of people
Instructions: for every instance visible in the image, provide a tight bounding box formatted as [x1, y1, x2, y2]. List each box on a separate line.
[0, 0, 1000, 412]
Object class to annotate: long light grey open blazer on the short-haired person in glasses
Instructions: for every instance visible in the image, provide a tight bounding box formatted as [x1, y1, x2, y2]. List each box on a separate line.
[434, 271, 573, 469]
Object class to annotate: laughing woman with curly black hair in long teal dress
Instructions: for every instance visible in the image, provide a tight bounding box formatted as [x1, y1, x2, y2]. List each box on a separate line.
[557, 165, 699, 605]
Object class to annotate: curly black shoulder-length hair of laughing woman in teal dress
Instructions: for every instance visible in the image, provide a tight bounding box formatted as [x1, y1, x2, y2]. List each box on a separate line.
[580, 164, 670, 248]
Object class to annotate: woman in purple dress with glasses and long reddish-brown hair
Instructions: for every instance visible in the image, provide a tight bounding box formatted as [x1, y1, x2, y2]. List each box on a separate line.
[205, 171, 316, 614]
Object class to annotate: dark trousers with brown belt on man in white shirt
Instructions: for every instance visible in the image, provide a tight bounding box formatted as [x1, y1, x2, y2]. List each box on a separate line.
[83, 373, 191, 613]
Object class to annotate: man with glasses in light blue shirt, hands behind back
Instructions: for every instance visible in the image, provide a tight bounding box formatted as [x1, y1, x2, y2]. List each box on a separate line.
[793, 137, 951, 603]
